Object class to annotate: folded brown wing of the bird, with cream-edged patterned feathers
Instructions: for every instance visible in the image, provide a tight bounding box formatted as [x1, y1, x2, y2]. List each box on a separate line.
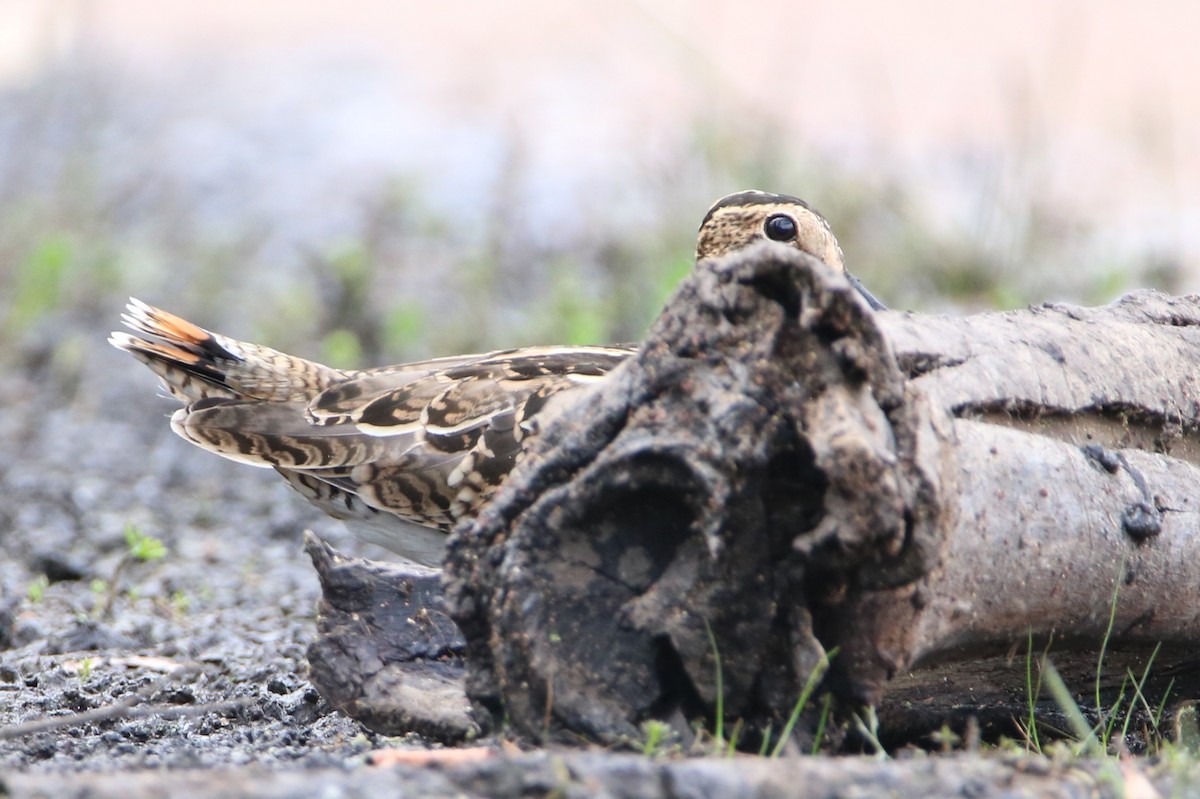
[172, 347, 632, 529]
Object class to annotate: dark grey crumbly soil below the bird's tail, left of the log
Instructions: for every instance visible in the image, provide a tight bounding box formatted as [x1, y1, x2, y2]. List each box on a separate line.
[0, 350, 383, 772]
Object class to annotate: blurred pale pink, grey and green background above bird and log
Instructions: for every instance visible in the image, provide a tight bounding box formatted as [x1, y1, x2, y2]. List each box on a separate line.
[0, 0, 1200, 386]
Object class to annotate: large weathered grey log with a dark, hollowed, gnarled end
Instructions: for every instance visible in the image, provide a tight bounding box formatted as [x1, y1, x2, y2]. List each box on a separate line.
[446, 239, 1200, 741]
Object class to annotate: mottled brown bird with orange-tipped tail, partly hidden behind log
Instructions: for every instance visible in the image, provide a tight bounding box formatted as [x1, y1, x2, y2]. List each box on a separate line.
[108, 191, 883, 567]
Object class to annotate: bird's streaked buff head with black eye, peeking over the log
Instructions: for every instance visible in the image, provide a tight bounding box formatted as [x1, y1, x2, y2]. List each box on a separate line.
[696, 191, 846, 271]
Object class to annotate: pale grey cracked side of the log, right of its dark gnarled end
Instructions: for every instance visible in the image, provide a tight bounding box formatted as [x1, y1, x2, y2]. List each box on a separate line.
[873, 292, 1200, 739]
